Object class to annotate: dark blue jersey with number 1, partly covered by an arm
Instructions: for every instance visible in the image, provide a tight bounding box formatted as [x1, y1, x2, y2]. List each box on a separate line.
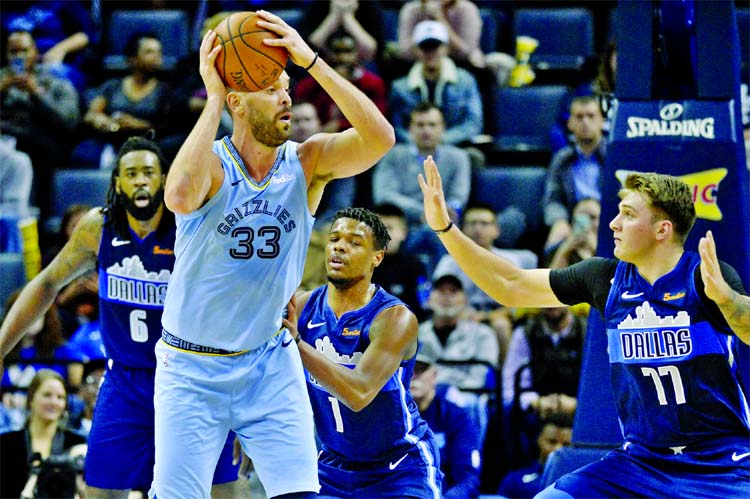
[299, 286, 429, 463]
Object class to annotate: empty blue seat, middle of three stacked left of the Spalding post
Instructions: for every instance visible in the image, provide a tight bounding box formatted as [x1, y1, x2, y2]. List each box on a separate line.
[492, 85, 568, 152]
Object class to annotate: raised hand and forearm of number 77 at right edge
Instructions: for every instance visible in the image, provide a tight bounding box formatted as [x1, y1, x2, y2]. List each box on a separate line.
[698, 230, 750, 345]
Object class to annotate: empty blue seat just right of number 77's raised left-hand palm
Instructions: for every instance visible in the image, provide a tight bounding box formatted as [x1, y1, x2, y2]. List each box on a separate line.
[471, 166, 547, 231]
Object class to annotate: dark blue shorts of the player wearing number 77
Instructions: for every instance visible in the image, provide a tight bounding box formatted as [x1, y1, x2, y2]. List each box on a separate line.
[537, 440, 750, 499]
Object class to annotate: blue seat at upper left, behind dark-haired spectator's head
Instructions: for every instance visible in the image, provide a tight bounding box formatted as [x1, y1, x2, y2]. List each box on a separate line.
[104, 10, 190, 71]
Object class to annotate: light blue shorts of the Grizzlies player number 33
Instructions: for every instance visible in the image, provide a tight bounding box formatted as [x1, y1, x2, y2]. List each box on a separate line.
[149, 331, 320, 499]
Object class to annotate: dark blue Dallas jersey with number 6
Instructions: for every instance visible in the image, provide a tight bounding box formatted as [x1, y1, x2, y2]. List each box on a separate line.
[97, 218, 175, 369]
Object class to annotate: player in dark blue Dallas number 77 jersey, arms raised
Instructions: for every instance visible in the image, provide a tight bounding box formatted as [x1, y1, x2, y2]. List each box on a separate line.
[419, 158, 750, 499]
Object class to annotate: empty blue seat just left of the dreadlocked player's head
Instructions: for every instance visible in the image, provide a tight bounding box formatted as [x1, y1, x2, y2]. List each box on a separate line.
[52, 169, 112, 217]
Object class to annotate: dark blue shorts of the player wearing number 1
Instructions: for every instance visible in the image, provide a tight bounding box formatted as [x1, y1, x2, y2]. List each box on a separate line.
[318, 438, 443, 499]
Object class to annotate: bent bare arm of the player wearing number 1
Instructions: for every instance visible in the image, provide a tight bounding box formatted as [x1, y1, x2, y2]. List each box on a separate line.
[282, 294, 417, 412]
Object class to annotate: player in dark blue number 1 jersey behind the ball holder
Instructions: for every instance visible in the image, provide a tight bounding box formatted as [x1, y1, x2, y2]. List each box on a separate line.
[283, 208, 441, 499]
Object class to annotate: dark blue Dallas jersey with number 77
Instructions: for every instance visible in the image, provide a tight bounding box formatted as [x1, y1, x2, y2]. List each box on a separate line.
[604, 252, 750, 448]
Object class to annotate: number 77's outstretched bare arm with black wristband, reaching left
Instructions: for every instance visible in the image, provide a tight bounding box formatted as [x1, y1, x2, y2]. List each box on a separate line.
[418, 156, 563, 307]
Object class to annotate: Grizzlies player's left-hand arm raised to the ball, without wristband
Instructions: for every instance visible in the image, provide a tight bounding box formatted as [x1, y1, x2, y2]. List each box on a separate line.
[164, 30, 226, 215]
